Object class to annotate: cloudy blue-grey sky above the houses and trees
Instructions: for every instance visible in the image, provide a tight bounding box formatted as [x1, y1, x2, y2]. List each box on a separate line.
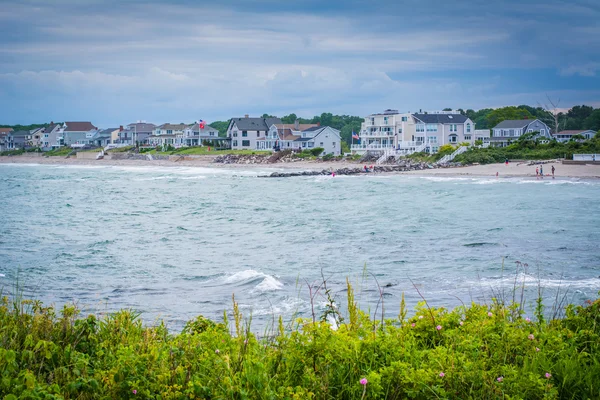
[0, 0, 600, 128]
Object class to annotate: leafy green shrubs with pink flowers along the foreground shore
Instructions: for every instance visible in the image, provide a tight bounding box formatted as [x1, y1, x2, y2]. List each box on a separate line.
[0, 284, 600, 400]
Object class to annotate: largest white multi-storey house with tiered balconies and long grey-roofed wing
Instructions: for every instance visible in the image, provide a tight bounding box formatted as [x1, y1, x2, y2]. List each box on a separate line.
[351, 109, 482, 155]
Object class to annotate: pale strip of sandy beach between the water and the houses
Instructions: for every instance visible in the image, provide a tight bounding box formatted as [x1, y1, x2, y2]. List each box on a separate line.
[0, 156, 600, 179]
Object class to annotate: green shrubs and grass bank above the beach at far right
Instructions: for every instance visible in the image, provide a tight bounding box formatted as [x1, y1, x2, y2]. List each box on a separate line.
[454, 132, 600, 164]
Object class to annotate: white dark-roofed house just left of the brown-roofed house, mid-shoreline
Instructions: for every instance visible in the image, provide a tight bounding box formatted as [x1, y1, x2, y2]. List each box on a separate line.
[227, 114, 281, 150]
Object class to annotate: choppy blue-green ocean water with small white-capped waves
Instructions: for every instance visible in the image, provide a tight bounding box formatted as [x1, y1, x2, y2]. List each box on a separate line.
[0, 164, 600, 331]
